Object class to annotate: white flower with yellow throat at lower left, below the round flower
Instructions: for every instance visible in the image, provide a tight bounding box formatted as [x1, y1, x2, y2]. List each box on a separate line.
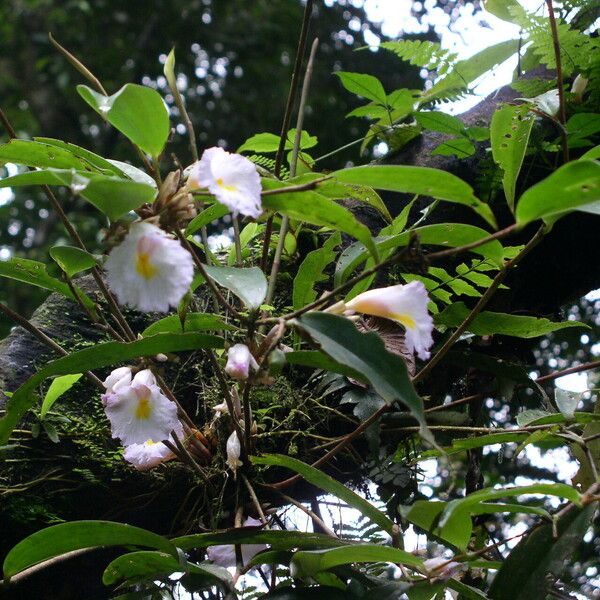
[102, 369, 182, 446]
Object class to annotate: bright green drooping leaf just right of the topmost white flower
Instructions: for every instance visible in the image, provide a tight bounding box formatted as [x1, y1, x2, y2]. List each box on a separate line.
[262, 191, 377, 256]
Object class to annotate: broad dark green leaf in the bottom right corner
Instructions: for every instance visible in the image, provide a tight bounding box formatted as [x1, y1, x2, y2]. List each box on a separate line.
[489, 504, 595, 600]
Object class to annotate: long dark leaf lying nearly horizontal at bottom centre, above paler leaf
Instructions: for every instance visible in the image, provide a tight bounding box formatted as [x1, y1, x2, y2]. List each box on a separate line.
[171, 527, 349, 551]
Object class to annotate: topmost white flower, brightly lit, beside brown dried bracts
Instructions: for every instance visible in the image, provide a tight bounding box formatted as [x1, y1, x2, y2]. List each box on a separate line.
[188, 148, 262, 219]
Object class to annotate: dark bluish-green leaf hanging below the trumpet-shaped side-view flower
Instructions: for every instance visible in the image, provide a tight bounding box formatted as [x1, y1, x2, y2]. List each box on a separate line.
[295, 312, 433, 441]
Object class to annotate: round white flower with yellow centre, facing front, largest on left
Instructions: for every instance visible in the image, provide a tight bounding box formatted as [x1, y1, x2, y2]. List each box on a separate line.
[105, 222, 194, 312]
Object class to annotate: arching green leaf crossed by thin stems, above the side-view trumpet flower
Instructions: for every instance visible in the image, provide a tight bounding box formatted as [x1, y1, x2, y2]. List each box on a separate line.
[334, 223, 504, 286]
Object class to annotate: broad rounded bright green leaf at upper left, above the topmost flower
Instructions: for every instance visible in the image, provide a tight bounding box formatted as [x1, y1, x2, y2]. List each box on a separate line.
[77, 83, 170, 157]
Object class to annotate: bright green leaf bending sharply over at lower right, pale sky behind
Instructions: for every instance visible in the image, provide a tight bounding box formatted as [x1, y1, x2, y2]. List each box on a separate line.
[438, 483, 581, 549]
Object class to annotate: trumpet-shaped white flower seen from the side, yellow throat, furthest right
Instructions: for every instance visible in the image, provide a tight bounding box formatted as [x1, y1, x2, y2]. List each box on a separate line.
[345, 281, 433, 359]
